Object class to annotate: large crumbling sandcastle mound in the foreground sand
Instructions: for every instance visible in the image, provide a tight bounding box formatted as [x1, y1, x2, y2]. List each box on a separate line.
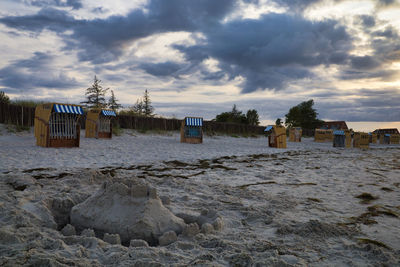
[71, 181, 185, 245]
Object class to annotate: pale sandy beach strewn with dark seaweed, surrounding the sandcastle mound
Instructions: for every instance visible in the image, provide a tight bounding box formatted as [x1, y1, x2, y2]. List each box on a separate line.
[0, 125, 400, 266]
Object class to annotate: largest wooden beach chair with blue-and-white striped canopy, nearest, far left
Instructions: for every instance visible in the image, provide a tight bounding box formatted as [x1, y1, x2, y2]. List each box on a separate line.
[35, 103, 83, 147]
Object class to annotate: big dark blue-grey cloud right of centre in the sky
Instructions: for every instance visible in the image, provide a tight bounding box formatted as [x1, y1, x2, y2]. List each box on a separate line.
[174, 14, 351, 93]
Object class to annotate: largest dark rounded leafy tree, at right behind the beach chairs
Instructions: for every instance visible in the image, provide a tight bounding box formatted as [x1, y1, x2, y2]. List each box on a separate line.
[285, 99, 323, 129]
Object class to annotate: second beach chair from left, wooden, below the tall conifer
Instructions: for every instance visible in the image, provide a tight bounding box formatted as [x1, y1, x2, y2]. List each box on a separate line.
[85, 109, 116, 138]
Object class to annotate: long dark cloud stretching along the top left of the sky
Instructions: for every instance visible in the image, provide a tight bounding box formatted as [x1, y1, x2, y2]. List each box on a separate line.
[0, 0, 235, 63]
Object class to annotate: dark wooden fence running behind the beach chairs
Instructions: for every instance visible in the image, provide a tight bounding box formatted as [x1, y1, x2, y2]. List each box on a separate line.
[0, 103, 265, 135]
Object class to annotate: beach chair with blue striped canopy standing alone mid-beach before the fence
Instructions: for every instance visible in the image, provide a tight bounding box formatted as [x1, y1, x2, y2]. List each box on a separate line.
[181, 117, 203, 144]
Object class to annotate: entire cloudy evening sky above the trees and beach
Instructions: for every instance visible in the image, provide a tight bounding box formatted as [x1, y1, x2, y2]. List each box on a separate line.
[0, 0, 400, 130]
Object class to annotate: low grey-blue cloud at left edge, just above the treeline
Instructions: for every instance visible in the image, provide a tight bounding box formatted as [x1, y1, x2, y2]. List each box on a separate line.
[0, 52, 77, 92]
